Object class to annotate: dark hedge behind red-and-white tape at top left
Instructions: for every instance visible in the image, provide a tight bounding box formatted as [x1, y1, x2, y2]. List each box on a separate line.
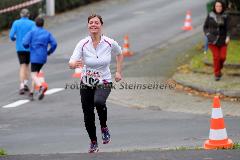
[0, 0, 100, 30]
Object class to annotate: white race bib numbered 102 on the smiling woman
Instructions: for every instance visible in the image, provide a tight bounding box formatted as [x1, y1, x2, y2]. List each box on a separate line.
[81, 67, 103, 87]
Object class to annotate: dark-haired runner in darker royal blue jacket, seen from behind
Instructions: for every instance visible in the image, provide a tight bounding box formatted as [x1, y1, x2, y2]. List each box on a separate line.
[23, 17, 57, 100]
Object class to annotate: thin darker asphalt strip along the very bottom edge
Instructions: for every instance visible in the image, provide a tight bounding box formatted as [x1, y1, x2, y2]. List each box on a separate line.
[0, 150, 240, 160]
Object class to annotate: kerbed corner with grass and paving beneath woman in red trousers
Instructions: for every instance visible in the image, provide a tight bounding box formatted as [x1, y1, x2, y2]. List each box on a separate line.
[173, 41, 240, 100]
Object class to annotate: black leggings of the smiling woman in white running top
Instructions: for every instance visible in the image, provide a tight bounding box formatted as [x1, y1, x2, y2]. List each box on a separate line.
[80, 85, 111, 141]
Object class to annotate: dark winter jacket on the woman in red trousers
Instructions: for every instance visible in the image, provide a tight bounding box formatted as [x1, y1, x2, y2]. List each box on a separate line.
[203, 12, 230, 46]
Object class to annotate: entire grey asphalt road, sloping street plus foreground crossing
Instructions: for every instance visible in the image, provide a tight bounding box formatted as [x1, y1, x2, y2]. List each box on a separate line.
[0, 0, 240, 154]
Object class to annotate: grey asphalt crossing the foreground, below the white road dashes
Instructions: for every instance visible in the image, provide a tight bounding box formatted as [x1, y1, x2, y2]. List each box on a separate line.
[0, 90, 240, 154]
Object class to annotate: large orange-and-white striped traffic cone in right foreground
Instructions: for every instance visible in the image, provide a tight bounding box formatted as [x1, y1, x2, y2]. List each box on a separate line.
[204, 96, 233, 149]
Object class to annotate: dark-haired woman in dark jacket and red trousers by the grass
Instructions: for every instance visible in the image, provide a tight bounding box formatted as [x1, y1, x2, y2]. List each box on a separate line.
[203, 0, 230, 81]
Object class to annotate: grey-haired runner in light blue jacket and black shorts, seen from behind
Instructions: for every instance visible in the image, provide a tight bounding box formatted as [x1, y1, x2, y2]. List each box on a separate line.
[9, 9, 35, 95]
